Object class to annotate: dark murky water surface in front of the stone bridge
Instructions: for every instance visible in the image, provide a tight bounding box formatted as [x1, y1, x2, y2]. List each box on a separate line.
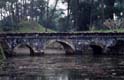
[0, 55, 124, 80]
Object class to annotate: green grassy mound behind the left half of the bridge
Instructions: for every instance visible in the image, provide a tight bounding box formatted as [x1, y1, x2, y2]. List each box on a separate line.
[0, 21, 55, 32]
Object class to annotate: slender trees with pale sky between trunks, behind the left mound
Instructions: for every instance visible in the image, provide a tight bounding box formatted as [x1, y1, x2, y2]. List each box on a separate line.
[0, 0, 46, 30]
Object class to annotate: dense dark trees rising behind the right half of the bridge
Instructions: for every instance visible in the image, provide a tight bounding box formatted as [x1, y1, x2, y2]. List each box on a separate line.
[65, 0, 124, 31]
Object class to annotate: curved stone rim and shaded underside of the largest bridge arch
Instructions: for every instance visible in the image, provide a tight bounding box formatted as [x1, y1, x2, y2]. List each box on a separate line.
[44, 40, 75, 54]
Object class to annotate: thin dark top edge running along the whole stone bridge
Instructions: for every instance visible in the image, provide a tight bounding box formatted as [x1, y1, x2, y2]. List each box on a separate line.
[0, 32, 124, 36]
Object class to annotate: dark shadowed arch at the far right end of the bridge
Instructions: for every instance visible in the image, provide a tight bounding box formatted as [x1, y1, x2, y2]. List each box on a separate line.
[108, 40, 124, 55]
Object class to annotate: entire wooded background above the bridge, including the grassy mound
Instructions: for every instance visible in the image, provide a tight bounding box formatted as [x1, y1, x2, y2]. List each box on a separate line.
[0, 0, 124, 32]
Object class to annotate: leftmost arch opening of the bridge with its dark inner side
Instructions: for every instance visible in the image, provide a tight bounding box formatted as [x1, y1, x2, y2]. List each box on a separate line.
[13, 44, 34, 55]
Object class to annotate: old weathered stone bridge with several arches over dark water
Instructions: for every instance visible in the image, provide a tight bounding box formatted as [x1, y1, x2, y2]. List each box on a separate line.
[0, 33, 124, 55]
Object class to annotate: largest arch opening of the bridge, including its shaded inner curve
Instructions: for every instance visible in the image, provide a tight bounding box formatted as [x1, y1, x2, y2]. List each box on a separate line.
[44, 40, 75, 55]
